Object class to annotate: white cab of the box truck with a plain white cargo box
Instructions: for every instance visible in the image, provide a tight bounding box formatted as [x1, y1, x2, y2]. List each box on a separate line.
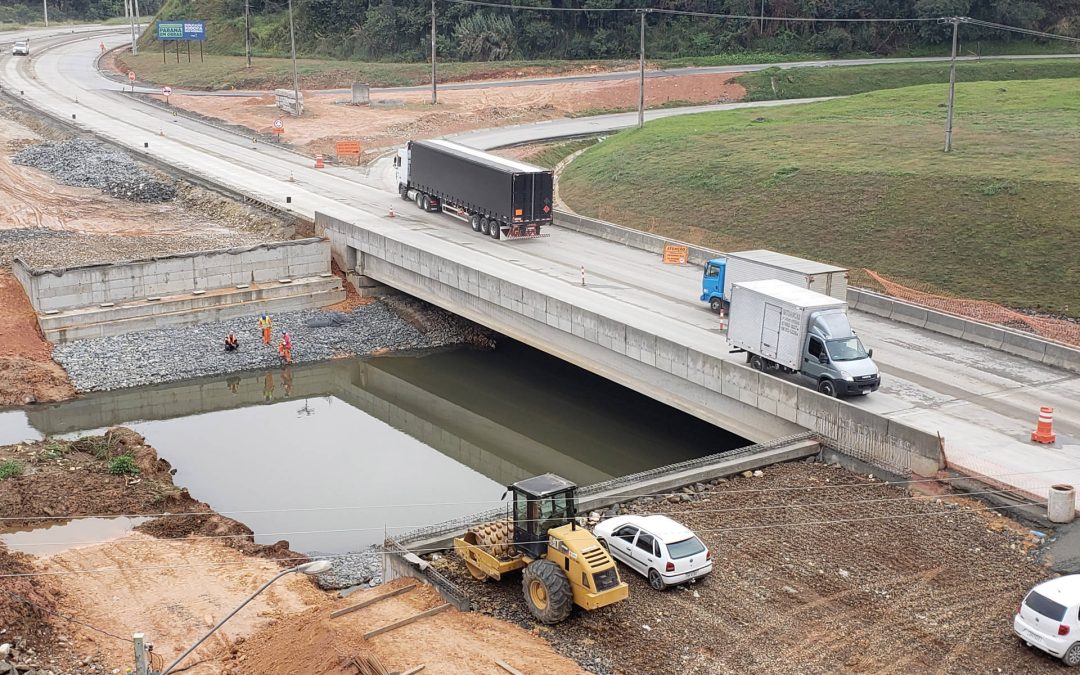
[801, 309, 881, 396]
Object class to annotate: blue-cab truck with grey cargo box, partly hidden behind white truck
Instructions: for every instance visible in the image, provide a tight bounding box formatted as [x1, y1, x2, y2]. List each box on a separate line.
[701, 248, 848, 312]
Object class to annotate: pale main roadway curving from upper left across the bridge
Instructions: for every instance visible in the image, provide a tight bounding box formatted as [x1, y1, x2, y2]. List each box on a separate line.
[0, 27, 1080, 494]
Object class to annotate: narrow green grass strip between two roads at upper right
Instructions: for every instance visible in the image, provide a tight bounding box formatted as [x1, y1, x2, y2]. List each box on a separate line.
[735, 58, 1080, 100]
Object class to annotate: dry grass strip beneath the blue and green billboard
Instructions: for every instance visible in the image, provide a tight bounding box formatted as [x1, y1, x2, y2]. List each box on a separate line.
[119, 48, 633, 90]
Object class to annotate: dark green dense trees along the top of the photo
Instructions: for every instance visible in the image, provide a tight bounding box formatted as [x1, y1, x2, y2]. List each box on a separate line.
[137, 0, 1080, 60]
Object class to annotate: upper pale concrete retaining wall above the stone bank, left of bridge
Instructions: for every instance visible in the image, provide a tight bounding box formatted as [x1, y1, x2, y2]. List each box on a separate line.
[13, 239, 330, 313]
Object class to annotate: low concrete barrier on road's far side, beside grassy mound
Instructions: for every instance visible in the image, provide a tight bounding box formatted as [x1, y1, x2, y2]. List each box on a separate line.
[554, 211, 1080, 373]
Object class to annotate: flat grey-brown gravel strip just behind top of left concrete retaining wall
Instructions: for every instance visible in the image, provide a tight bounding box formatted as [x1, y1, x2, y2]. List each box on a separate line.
[0, 228, 266, 269]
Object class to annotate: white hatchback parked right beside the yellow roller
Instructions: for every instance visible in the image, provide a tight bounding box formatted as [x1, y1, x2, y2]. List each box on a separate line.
[593, 515, 713, 591]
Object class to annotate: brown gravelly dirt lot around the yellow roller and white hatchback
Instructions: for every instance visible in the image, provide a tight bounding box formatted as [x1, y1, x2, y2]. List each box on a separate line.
[434, 463, 1061, 674]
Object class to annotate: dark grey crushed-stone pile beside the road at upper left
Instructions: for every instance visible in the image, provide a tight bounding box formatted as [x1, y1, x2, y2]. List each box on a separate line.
[12, 138, 176, 203]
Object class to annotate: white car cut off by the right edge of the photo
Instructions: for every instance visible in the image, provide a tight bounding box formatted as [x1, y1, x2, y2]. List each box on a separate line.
[1013, 575, 1080, 665]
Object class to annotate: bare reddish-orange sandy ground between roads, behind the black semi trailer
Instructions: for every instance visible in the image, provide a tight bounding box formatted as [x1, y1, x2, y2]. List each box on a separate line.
[159, 73, 745, 154]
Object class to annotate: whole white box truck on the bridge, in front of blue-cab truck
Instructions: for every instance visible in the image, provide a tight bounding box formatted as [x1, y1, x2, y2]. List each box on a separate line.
[728, 279, 881, 396]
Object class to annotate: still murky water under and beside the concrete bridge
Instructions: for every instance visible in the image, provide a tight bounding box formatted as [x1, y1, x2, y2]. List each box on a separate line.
[0, 342, 746, 552]
